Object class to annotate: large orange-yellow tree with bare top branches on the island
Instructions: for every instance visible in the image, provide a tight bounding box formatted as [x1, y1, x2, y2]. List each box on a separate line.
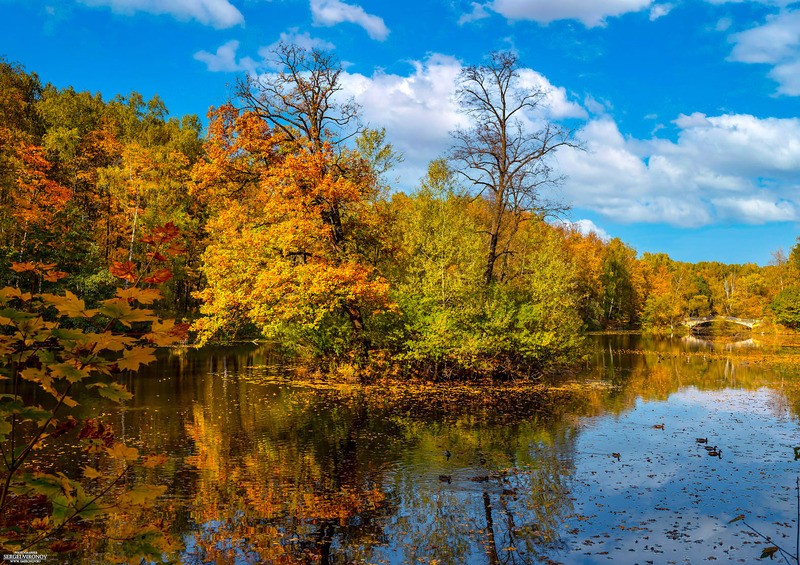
[195, 46, 391, 357]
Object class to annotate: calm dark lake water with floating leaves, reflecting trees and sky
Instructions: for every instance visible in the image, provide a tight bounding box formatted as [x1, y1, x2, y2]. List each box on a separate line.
[84, 335, 800, 564]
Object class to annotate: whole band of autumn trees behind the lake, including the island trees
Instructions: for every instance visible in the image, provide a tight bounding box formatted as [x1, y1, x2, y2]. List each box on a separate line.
[0, 51, 800, 378]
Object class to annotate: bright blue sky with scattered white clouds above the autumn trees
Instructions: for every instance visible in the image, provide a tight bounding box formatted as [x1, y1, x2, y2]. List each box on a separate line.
[0, 0, 800, 264]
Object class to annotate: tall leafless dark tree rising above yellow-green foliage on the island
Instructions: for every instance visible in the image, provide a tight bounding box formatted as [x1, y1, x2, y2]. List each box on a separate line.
[450, 52, 578, 286]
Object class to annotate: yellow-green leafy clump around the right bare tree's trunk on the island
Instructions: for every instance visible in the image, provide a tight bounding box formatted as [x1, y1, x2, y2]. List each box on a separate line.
[392, 161, 582, 379]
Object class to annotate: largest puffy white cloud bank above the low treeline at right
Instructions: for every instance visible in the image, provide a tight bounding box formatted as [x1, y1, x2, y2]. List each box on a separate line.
[558, 113, 800, 227]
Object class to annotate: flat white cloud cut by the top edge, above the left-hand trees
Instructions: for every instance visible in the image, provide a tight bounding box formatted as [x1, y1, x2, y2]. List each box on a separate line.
[80, 0, 244, 29]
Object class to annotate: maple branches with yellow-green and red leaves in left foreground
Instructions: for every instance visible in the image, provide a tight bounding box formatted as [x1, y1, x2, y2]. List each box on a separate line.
[0, 224, 187, 560]
